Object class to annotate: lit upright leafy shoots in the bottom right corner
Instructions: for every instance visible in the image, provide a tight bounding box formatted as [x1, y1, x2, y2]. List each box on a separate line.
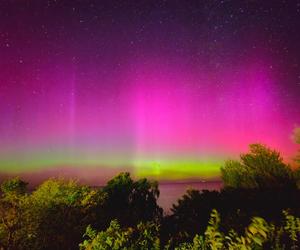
[175, 210, 300, 250]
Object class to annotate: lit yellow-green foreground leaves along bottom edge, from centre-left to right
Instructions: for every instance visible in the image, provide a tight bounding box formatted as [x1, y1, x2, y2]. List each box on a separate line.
[80, 210, 300, 250]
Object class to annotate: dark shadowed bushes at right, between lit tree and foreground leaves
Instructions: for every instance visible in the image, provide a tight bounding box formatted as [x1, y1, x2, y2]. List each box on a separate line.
[161, 184, 300, 247]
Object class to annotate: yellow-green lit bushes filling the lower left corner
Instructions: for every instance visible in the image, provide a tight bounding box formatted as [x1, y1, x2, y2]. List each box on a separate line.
[0, 178, 105, 250]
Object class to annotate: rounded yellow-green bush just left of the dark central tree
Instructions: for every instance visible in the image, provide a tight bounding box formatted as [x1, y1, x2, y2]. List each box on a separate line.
[27, 179, 105, 249]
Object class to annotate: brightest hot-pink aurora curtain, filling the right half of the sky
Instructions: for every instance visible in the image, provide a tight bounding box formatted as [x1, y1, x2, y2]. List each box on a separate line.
[130, 58, 296, 159]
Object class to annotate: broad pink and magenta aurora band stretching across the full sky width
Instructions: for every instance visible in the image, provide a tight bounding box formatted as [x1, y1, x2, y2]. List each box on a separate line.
[0, 55, 299, 175]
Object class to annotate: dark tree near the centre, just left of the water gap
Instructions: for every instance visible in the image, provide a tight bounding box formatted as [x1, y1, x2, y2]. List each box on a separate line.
[100, 173, 162, 229]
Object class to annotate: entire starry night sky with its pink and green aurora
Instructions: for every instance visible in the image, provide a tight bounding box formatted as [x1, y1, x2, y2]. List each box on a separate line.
[0, 0, 300, 179]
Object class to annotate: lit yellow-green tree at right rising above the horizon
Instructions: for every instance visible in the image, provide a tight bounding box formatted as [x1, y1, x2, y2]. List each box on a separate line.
[221, 144, 296, 188]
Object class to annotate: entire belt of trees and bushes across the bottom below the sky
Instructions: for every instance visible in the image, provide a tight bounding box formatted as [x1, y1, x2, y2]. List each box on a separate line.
[0, 141, 300, 250]
